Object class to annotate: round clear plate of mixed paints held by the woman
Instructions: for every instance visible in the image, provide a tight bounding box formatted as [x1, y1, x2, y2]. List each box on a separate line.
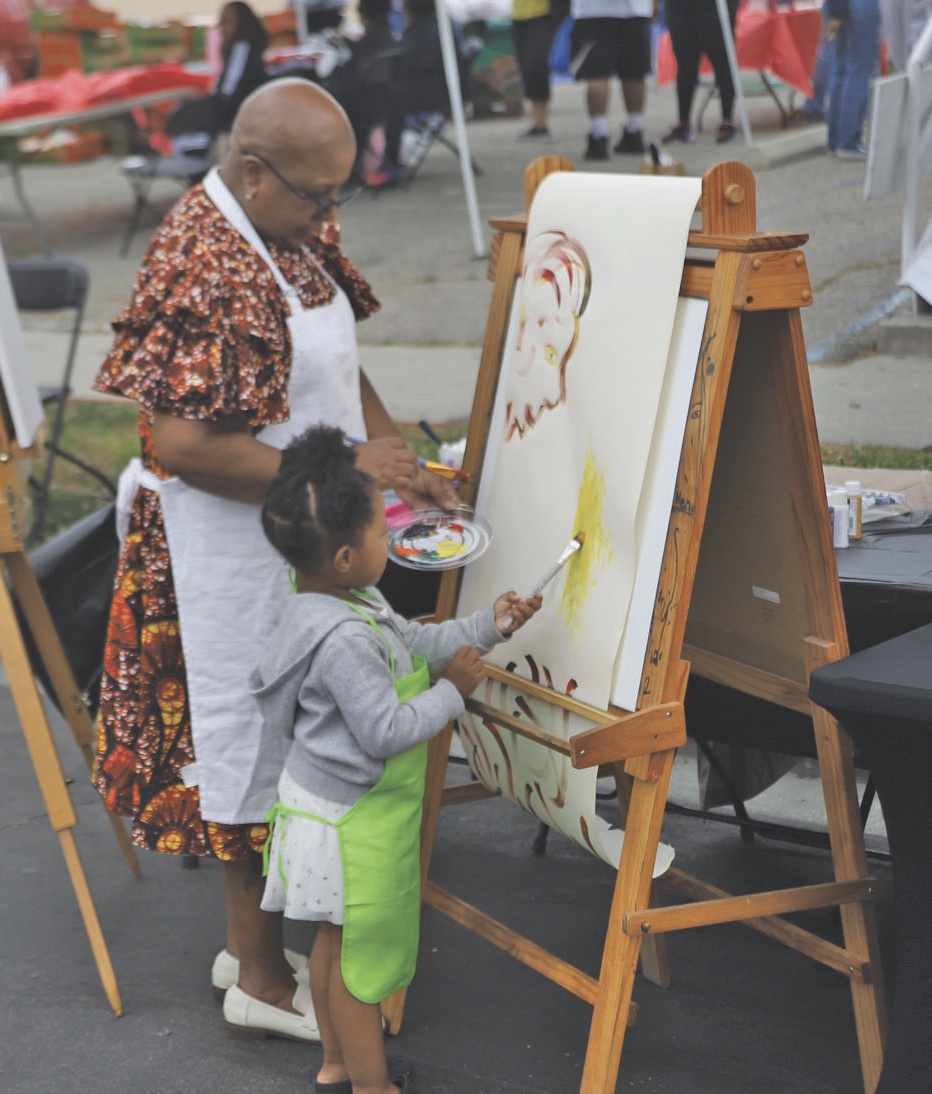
[388, 505, 492, 570]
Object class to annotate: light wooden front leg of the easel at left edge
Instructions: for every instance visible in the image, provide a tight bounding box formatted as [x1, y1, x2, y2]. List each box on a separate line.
[0, 556, 123, 1015]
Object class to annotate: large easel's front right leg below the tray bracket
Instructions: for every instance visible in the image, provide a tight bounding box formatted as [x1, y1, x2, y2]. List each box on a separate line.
[580, 749, 676, 1094]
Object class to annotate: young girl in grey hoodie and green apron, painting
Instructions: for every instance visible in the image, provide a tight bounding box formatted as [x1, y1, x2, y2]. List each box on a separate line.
[251, 427, 540, 1094]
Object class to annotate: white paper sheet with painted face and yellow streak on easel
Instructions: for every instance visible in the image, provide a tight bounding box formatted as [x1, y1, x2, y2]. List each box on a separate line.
[459, 166, 701, 709]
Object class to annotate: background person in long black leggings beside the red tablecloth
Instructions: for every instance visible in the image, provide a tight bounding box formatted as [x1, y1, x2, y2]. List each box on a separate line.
[663, 0, 738, 144]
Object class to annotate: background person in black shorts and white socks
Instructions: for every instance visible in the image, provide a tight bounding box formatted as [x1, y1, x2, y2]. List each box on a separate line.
[570, 0, 656, 160]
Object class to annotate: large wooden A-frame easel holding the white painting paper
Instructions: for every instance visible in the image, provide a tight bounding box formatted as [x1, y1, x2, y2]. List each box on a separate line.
[388, 158, 886, 1094]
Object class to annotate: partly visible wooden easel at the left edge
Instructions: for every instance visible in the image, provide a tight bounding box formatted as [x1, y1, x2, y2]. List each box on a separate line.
[0, 389, 140, 1015]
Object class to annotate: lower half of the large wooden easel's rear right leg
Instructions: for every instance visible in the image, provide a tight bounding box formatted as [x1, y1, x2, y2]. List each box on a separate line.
[805, 639, 887, 1094]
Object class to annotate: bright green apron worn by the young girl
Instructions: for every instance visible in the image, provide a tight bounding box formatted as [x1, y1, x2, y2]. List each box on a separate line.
[265, 604, 430, 1003]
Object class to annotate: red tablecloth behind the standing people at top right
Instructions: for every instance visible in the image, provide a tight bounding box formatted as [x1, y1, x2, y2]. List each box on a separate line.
[656, 8, 822, 95]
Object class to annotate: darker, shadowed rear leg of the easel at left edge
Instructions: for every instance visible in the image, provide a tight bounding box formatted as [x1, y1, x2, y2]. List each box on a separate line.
[5, 552, 142, 877]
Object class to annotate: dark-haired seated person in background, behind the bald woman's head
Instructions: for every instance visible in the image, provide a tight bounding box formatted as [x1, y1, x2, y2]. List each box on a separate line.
[166, 0, 268, 159]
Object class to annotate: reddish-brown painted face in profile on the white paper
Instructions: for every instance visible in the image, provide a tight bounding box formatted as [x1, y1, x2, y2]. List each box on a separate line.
[504, 231, 591, 441]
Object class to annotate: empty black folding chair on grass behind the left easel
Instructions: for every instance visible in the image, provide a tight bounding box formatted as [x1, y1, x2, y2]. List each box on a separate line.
[8, 258, 116, 540]
